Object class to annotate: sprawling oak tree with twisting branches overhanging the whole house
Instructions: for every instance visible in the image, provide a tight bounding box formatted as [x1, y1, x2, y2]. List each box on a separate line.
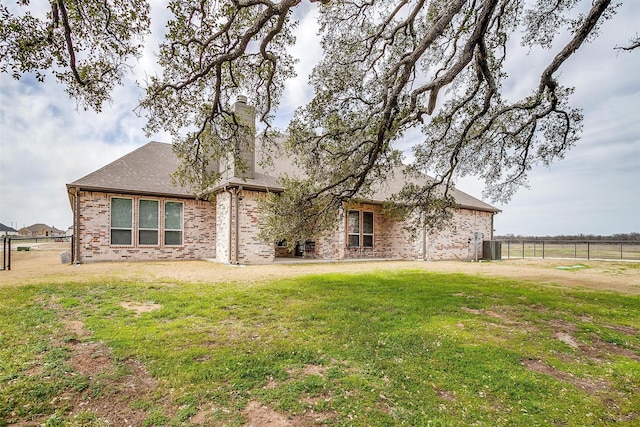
[0, 0, 638, 246]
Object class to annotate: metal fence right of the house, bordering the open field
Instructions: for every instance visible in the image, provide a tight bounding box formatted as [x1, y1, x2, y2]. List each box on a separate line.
[501, 240, 640, 261]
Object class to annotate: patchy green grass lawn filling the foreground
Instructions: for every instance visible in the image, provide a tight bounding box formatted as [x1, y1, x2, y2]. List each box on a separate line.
[0, 271, 640, 426]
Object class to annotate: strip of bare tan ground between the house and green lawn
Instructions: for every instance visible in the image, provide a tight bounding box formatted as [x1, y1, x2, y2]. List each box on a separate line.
[0, 243, 640, 295]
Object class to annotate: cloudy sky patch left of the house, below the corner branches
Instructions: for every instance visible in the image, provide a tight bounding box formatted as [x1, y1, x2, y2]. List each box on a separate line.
[0, 75, 165, 229]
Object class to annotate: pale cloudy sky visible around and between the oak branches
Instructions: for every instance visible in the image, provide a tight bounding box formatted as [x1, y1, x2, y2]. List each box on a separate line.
[0, 0, 640, 236]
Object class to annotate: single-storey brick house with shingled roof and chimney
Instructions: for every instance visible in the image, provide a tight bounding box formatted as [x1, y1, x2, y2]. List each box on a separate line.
[67, 99, 499, 264]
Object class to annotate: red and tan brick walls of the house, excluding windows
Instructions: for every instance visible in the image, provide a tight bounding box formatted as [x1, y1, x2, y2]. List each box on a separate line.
[79, 190, 493, 264]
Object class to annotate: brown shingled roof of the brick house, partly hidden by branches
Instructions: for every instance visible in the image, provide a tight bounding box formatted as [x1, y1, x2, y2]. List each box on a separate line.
[67, 138, 500, 212]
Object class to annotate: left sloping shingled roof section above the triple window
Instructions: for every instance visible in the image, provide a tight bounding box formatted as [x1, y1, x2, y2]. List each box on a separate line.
[67, 141, 195, 198]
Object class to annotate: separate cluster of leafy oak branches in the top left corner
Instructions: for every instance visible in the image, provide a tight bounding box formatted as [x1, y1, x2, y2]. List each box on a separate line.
[0, 0, 149, 111]
